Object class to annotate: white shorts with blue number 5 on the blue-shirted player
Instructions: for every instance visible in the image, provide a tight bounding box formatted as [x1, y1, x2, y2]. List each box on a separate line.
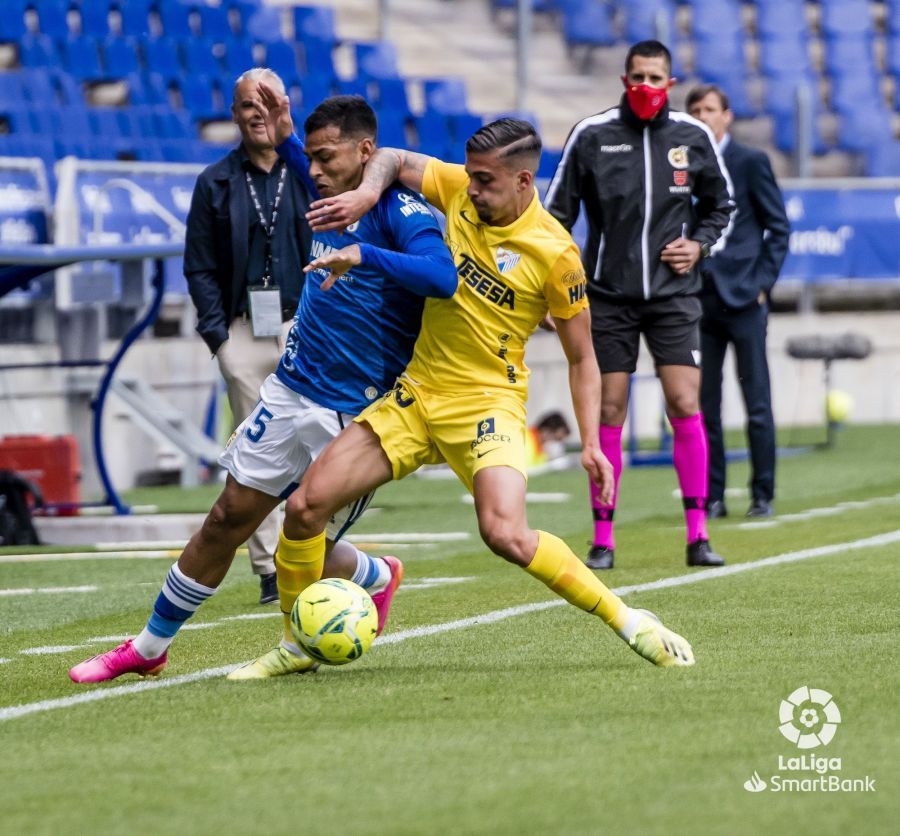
[219, 374, 373, 540]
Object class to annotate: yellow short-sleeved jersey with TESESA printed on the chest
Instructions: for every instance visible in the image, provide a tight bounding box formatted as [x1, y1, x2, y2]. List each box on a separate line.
[406, 159, 588, 401]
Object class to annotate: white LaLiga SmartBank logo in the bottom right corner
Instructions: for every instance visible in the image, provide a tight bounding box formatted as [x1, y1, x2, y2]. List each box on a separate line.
[744, 685, 875, 793]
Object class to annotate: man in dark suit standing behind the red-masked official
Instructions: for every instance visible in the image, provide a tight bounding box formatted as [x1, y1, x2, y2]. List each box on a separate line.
[686, 84, 790, 517]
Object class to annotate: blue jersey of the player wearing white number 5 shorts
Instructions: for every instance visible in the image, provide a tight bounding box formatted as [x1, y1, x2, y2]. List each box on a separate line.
[276, 140, 446, 415]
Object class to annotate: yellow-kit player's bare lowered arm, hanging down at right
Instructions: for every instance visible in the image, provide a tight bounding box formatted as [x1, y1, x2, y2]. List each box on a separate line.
[553, 310, 615, 504]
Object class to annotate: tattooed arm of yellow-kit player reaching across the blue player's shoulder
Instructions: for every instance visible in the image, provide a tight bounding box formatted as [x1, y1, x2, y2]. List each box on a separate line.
[306, 148, 431, 232]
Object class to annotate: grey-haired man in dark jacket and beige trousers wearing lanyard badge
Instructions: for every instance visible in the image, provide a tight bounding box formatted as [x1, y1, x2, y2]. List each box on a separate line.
[184, 68, 312, 604]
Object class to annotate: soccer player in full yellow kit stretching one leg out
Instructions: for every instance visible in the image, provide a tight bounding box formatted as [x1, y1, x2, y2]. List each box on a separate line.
[230, 119, 694, 679]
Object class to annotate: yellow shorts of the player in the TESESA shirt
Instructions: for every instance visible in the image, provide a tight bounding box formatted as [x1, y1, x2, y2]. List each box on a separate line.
[354, 381, 528, 492]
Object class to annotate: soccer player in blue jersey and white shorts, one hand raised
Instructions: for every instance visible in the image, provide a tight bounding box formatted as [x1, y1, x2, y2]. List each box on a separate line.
[69, 77, 457, 682]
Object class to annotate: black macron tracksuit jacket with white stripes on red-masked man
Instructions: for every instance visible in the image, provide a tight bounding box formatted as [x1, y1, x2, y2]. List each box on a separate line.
[544, 96, 734, 302]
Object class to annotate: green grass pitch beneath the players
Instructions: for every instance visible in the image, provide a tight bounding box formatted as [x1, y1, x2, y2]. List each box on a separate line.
[0, 427, 900, 834]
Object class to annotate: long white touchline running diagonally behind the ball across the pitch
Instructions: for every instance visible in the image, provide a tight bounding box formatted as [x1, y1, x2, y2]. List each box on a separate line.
[0, 529, 900, 722]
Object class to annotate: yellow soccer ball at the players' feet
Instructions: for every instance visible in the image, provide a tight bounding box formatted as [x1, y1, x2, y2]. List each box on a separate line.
[291, 578, 378, 665]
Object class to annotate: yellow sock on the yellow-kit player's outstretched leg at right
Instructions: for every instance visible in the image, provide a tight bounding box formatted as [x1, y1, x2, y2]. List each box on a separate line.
[525, 531, 629, 631]
